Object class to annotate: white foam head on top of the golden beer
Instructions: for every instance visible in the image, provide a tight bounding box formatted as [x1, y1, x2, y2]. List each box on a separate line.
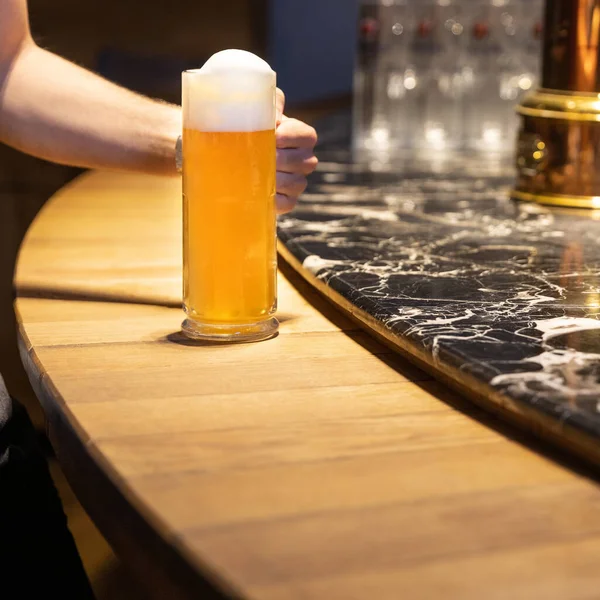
[183, 50, 276, 132]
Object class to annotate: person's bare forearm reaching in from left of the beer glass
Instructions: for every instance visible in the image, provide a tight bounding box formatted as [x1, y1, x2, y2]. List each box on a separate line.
[0, 0, 181, 173]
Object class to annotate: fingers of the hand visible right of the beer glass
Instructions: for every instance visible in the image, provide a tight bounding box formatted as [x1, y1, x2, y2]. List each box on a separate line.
[275, 90, 318, 214]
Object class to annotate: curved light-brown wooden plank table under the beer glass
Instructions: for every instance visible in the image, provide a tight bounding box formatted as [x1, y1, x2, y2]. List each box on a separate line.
[16, 173, 600, 600]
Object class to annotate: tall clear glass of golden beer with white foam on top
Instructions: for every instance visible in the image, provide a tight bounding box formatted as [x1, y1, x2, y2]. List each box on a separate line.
[182, 50, 278, 341]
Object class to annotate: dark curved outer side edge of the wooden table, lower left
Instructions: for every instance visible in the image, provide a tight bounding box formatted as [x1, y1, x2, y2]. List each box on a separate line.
[16, 316, 242, 600]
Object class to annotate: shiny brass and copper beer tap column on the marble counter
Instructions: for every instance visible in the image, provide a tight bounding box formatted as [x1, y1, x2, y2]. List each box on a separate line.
[512, 0, 600, 208]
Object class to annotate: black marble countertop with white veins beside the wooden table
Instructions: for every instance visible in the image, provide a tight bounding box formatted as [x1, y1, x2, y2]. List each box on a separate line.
[279, 113, 600, 463]
